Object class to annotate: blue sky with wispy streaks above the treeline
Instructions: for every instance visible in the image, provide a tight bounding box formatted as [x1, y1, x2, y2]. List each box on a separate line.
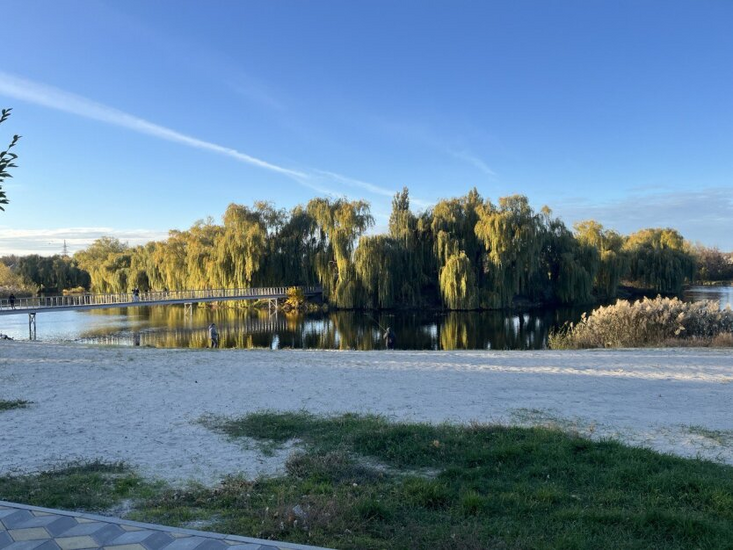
[0, 0, 733, 255]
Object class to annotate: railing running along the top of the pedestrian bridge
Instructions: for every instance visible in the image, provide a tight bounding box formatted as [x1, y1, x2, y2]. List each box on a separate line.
[0, 286, 322, 310]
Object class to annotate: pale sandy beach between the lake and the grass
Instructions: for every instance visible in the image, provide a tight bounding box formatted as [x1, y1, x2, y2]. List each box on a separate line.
[0, 342, 733, 483]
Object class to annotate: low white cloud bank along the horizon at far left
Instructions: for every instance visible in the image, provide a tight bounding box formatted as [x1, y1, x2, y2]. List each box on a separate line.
[0, 227, 168, 256]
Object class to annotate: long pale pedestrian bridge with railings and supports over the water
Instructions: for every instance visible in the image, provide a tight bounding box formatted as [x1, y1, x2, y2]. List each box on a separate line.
[0, 286, 323, 338]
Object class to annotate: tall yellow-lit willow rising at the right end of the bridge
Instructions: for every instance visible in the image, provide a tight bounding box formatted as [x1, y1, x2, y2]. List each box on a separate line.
[307, 198, 374, 309]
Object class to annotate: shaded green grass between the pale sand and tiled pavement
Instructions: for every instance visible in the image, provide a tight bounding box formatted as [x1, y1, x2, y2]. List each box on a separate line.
[0, 418, 733, 550]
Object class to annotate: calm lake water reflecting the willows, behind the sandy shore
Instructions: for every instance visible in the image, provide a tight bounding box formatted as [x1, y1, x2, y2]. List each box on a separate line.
[0, 287, 733, 350]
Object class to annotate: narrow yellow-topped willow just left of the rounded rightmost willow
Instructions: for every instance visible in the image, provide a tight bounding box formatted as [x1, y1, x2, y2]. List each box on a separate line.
[573, 220, 629, 299]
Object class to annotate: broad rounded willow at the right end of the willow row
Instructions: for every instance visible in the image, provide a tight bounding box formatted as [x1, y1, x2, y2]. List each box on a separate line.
[624, 228, 695, 294]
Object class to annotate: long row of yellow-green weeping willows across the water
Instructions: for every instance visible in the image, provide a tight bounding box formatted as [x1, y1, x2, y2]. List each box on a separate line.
[74, 189, 695, 309]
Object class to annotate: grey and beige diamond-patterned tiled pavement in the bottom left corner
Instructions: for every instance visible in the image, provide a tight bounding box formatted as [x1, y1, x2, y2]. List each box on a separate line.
[0, 500, 332, 550]
